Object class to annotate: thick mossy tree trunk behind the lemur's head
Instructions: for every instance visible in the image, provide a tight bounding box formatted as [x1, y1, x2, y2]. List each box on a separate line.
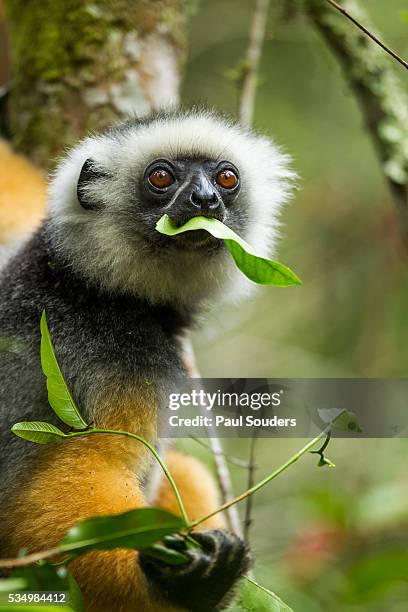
[6, 0, 192, 168]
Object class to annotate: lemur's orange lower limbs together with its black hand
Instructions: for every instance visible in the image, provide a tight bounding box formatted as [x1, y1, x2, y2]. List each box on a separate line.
[4, 408, 248, 612]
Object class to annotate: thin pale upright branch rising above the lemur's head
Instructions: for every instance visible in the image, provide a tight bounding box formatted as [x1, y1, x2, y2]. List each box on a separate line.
[239, 0, 269, 126]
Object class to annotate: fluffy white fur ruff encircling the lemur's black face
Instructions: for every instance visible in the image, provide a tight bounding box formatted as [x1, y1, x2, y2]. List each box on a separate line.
[49, 111, 294, 305]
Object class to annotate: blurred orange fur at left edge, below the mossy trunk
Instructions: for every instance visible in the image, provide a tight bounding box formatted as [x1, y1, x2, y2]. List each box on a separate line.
[0, 141, 46, 244]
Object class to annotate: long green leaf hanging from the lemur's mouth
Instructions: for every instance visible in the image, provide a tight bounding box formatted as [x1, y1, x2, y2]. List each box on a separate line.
[156, 215, 302, 287]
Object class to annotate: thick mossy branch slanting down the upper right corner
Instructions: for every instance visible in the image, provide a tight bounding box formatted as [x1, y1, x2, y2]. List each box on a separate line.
[301, 0, 408, 246]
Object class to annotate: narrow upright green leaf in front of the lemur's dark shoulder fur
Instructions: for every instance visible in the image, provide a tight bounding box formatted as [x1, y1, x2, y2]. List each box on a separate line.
[41, 311, 87, 429]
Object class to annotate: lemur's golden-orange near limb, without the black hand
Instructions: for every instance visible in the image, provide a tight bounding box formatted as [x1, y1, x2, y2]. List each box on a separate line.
[7, 436, 160, 612]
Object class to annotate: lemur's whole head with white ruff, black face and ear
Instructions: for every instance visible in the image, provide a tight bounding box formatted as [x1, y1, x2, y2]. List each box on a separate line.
[49, 111, 292, 305]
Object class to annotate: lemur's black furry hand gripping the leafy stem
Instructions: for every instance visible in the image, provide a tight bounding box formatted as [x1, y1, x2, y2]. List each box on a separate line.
[140, 530, 250, 612]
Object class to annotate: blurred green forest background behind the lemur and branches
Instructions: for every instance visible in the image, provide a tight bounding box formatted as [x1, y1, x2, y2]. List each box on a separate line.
[0, 0, 408, 612]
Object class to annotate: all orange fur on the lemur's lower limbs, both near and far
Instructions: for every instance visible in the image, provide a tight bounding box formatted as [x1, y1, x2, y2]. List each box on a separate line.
[7, 434, 222, 612]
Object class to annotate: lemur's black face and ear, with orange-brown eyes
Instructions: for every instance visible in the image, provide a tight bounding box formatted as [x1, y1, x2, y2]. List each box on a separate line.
[77, 159, 242, 251]
